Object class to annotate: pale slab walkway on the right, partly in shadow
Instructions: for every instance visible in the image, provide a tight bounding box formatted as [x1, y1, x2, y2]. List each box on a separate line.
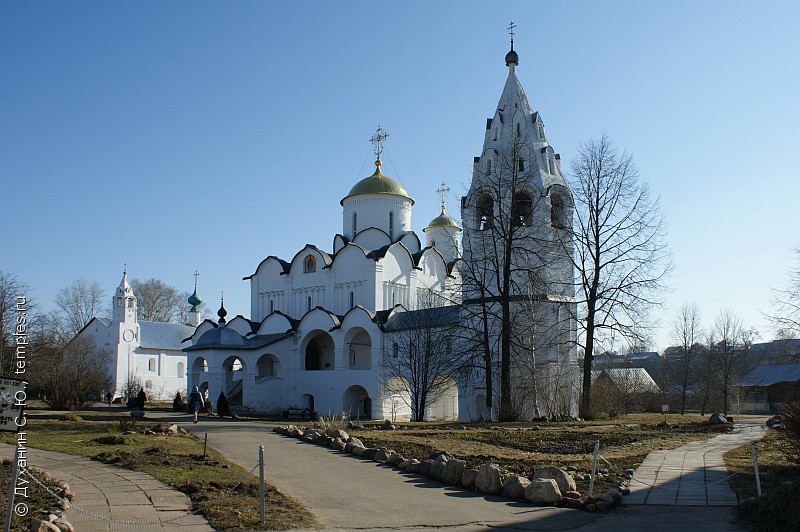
[623, 417, 767, 506]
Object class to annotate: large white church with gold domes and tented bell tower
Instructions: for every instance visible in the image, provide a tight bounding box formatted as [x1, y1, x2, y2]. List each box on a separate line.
[184, 41, 577, 420]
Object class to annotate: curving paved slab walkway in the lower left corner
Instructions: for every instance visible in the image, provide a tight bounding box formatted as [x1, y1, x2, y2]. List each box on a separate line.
[0, 444, 213, 532]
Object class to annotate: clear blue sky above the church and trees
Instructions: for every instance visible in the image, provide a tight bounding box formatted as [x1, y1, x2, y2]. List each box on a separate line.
[0, 1, 800, 347]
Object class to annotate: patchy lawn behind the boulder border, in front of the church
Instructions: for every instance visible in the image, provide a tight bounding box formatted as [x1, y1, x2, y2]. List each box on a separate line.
[348, 414, 726, 494]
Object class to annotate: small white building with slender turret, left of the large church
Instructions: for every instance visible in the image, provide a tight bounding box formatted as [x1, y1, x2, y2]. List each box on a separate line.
[77, 272, 195, 400]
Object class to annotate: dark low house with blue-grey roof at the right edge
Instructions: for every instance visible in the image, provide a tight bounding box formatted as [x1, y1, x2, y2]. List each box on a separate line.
[739, 364, 800, 414]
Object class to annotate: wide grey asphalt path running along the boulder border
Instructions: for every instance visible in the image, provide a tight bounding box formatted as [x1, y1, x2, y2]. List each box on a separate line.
[148, 413, 749, 532]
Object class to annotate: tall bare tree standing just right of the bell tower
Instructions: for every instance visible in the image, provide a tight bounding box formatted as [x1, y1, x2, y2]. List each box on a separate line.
[570, 134, 671, 417]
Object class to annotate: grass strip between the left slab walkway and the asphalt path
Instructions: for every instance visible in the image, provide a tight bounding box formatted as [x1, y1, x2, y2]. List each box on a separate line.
[0, 412, 316, 530]
